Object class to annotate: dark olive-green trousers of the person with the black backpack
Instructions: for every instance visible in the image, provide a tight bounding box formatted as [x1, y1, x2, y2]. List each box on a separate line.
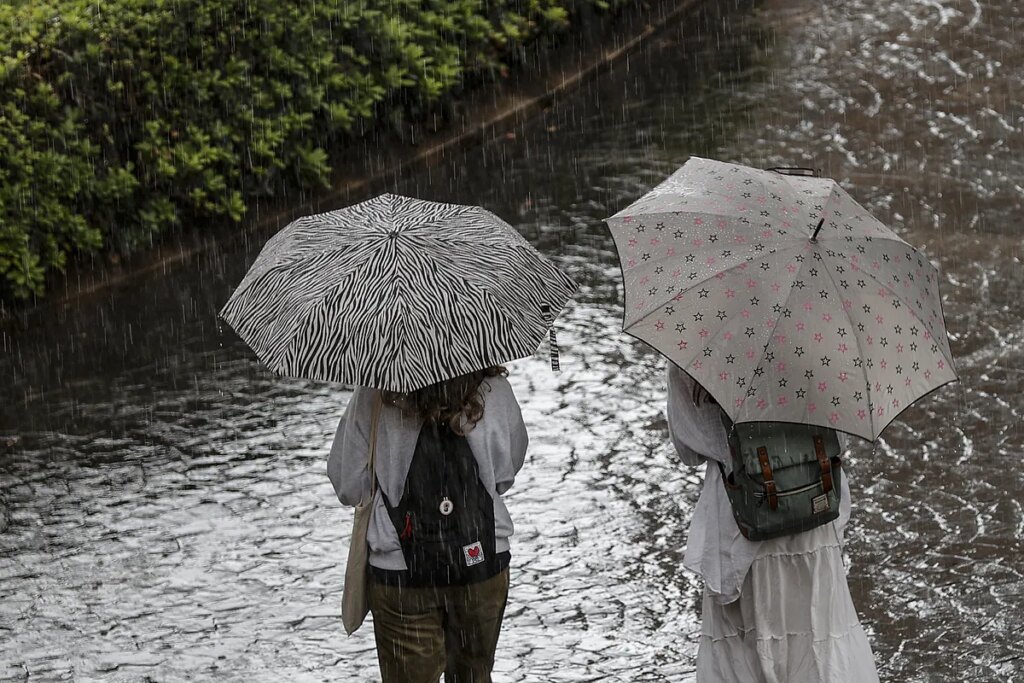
[370, 568, 509, 683]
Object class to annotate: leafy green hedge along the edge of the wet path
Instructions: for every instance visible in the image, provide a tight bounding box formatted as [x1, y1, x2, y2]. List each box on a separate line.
[0, 0, 622, 300]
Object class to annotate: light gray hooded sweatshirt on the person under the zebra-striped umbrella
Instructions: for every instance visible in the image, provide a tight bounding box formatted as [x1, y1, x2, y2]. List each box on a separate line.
[327, 376, 528, 569]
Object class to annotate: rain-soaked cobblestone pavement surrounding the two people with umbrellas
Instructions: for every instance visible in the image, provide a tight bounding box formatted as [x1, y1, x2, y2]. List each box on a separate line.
[0, 0, 1024, 683]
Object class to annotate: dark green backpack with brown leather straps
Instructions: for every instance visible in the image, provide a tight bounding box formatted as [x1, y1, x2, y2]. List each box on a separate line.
[719, 418, 843, 541]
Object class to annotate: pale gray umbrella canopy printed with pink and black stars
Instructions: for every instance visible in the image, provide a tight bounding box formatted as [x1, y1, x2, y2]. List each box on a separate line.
[607, 158, 956, 440]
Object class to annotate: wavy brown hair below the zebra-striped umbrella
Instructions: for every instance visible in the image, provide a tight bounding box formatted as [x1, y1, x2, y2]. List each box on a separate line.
[383, 366, 508, 434]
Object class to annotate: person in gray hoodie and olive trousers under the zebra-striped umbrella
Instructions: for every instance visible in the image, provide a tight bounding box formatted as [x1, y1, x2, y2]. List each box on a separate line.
[328, 368, 528, 683]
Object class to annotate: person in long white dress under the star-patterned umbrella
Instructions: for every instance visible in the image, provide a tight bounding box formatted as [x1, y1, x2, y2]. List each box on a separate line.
[668, 362, 879, 683]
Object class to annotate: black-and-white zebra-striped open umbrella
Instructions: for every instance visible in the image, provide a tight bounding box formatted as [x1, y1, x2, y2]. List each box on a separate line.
[220, 195, 577, 392]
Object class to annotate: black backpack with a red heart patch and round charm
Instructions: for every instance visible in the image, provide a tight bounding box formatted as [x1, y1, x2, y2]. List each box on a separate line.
[384, 421, 501, 587]
